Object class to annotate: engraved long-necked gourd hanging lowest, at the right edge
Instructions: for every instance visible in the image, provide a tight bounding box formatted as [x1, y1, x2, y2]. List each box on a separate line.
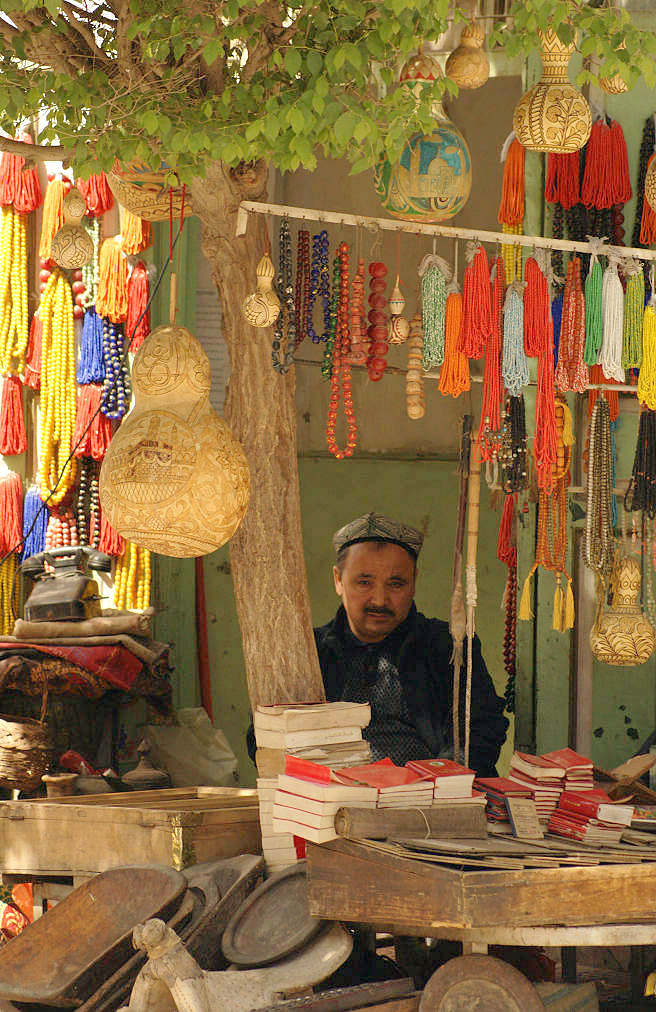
[590, 558, 656, 666]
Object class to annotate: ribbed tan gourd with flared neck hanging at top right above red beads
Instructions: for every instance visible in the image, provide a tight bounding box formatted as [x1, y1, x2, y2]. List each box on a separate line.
[512, 28, 592, 155]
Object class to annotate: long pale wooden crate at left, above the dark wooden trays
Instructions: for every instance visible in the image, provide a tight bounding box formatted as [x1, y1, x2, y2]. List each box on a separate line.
[0, 787, 261, 877]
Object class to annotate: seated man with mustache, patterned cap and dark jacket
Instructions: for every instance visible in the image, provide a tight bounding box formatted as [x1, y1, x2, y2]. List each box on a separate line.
[315, 513, 508, 776]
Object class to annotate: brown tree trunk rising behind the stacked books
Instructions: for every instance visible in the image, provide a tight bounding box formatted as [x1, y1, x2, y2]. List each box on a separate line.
[191, 163, 325, 706]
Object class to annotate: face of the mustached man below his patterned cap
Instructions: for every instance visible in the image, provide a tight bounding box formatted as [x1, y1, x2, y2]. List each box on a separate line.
[333, 541, 415, 643]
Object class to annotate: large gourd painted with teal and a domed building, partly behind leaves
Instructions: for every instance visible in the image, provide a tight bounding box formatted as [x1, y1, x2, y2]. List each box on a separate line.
[374, 55, 472, 222]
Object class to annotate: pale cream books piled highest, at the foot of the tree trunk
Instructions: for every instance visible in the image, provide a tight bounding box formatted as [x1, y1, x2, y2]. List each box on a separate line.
[253, 702, 372, 777]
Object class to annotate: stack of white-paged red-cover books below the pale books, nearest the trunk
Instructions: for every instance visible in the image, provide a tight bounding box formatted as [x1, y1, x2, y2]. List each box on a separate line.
[272, 756, 378, 843]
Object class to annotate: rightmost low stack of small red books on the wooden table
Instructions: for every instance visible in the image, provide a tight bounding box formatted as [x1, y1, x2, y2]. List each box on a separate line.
[549, 790, 634, 846]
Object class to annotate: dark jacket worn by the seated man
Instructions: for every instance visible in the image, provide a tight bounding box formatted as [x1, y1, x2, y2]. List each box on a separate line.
[315, 604, 508, 776]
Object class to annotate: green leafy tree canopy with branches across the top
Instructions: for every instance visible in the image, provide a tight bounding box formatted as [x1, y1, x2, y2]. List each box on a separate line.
[0, 0, 656, 180]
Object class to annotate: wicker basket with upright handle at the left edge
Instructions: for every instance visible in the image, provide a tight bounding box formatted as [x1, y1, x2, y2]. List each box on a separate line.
[0, 681, 52, 791]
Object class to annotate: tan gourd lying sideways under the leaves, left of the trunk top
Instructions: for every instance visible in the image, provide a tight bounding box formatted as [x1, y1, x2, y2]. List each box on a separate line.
[107, 161, 192, 222]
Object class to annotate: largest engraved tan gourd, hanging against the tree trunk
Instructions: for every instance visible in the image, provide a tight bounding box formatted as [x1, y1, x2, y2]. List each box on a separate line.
[100, 326, 250, 558]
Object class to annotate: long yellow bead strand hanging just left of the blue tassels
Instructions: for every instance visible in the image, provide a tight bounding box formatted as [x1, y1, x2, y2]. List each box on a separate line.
[38, 270, 77, 506]
